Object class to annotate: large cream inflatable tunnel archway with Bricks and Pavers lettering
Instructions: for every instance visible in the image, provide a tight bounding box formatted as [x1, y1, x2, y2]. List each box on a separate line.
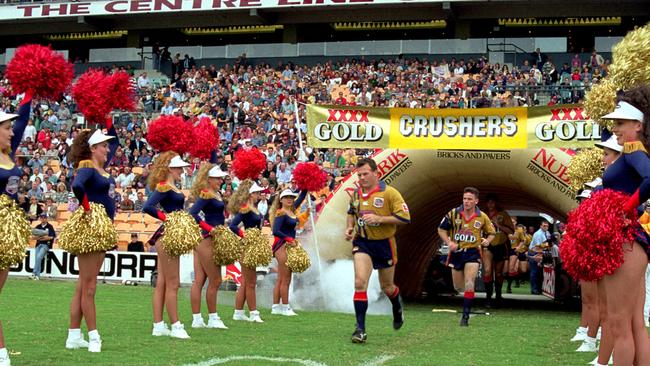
[315, 148, 576, 296]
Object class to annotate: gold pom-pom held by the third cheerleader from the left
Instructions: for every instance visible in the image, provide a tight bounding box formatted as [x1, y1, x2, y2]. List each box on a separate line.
[160, 211, 202, 257]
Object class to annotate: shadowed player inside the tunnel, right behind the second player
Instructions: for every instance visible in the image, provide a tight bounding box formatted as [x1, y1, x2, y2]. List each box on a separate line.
[483, 194, 515, 307]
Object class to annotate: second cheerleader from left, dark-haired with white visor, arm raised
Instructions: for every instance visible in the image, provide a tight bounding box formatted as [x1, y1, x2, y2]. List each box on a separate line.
[65, 118, 119, 352]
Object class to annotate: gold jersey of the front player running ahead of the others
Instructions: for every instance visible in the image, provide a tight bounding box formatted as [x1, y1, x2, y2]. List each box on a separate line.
[348, 182, 411, 240]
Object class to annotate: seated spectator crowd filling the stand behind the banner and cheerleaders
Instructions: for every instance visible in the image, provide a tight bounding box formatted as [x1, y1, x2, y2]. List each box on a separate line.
[0, 51, 608, 227]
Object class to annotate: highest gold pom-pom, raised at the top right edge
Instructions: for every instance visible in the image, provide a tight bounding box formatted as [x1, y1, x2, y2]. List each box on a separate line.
[609, 24, 650, 90]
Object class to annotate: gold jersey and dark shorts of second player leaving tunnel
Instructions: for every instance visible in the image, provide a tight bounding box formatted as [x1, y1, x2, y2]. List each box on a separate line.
[439, 205, 496, 271]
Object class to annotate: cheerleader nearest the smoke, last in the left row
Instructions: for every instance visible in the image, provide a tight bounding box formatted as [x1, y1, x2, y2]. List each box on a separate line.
[270, 189, 307, 316]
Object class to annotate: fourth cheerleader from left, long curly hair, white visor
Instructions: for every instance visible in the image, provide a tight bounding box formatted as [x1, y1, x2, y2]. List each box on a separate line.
[189, 164, 228, 329]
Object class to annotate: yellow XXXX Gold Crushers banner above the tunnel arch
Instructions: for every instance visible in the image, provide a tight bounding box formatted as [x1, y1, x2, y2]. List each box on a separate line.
[307, 105, 600, 150]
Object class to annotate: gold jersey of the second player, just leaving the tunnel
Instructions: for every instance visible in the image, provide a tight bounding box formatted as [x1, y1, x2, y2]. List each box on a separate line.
[439, 206, 496, 249]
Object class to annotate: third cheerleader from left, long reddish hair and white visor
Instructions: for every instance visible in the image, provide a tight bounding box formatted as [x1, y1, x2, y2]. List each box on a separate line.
[143, 151, 190, 339]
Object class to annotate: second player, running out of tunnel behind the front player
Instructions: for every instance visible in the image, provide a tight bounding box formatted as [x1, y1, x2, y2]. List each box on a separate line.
[438, 187, 496, 327]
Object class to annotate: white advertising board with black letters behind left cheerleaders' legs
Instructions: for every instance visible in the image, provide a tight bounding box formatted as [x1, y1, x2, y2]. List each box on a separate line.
[9, 248, 243, 285]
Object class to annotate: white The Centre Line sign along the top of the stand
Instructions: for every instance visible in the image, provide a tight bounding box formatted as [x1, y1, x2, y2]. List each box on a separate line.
[0, 0, 446, 21]
